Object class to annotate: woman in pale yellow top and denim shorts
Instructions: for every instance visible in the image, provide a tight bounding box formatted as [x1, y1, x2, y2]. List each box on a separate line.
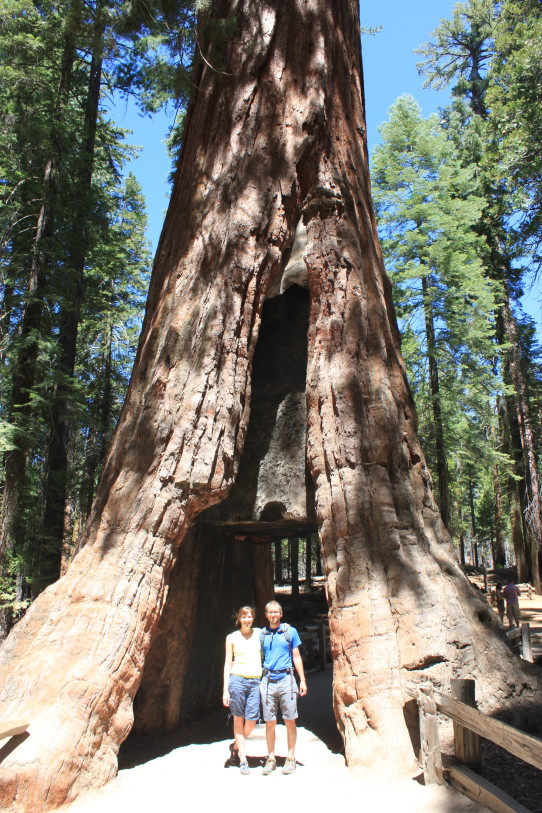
[222, 606, 262, 775]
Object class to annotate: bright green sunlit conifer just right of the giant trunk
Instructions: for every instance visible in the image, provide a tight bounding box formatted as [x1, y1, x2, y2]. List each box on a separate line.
[372, 96, 499, 530]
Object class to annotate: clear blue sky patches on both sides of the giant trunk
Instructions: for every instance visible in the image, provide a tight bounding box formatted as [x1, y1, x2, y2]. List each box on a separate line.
[113, 0, 462, 250]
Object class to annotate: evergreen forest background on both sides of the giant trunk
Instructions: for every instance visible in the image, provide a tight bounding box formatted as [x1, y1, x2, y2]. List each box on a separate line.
[0, 0, 542, 636]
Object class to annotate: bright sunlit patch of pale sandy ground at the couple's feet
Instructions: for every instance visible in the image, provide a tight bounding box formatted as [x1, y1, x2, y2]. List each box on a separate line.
[58, 726, 487, 813]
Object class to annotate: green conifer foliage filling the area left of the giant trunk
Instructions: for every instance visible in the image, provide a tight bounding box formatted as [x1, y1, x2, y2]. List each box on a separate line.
[0, 0, 176, 607]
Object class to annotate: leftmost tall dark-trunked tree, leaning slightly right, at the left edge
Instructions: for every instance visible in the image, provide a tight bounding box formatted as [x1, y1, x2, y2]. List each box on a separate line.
[0, 3, 79, 616]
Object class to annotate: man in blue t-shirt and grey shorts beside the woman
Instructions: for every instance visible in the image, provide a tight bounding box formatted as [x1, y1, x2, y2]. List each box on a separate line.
[260, 601, 307, 775]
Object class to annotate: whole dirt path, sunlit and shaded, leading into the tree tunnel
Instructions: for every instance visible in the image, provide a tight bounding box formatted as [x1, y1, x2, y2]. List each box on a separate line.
[62, 669, 492, 813]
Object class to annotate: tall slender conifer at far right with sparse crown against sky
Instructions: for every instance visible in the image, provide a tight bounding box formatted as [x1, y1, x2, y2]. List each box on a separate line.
[419, 0, 542, 592]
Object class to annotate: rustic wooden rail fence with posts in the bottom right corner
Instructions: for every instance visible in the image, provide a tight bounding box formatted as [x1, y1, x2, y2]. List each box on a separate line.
[408, 680, 542, 813]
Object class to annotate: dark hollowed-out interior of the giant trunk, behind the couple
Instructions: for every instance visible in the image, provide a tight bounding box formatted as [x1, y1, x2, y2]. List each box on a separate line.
[134, 282, 316, 734]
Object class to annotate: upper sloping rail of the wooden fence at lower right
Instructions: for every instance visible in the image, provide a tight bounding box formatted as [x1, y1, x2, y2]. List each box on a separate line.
[435, 692, 542, 771]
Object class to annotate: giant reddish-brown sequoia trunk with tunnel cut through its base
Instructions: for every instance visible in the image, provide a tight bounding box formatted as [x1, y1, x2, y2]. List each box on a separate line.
[0, 0, 540, 810]
